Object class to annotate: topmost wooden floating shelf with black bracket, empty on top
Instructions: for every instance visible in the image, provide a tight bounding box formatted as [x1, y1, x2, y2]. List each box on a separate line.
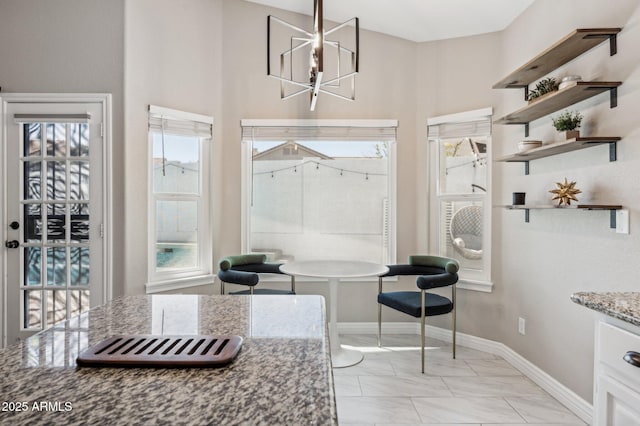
[493, 28, 622, 89]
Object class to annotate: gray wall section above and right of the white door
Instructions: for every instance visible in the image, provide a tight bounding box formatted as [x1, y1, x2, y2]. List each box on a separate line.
[0, 0, 125, 294]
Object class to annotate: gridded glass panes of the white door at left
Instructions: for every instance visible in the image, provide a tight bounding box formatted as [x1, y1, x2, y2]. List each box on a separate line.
[19, 122, 90, 330]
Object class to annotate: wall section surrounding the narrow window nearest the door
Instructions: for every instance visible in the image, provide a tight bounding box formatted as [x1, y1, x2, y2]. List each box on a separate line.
[119, 0, 223, 294]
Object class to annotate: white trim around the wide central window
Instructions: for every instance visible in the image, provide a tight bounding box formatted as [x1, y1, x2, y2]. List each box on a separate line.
[240, 119, 398, 270]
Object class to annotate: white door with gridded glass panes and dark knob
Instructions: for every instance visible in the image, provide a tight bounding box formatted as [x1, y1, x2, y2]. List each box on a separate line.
[3, 96, 108, 344]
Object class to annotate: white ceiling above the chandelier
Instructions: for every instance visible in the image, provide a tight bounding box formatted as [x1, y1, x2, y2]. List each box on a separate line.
[248, 0, 534, 42]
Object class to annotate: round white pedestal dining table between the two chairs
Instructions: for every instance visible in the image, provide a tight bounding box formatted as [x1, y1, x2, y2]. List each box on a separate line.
[280, 260, 389, 368]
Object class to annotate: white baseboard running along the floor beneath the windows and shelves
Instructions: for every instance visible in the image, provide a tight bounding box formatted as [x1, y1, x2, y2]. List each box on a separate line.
[338, 322, 593, 424]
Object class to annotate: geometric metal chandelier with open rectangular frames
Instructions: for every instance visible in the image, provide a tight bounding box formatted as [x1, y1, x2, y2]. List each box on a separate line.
[267, 0, 360, 111]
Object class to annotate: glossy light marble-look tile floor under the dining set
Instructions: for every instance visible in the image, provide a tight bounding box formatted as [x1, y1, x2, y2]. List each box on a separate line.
[333, 335, 585, 426]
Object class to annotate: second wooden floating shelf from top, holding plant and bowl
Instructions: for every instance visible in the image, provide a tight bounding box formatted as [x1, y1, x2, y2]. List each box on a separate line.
[495, 81, 622, 125]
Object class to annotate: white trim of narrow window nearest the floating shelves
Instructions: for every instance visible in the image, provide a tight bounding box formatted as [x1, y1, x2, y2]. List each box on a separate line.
[427, 107, 493, 293]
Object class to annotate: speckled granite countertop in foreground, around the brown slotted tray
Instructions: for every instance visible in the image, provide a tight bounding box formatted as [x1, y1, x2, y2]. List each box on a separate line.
[0, 295, 337, 426]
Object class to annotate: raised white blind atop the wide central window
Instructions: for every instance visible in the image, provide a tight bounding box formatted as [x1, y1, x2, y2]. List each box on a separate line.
[241, 120, 398, 141]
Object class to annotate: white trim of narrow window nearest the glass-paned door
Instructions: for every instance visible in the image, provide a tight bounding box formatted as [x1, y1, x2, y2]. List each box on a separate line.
[145, 105, 214, 294]
